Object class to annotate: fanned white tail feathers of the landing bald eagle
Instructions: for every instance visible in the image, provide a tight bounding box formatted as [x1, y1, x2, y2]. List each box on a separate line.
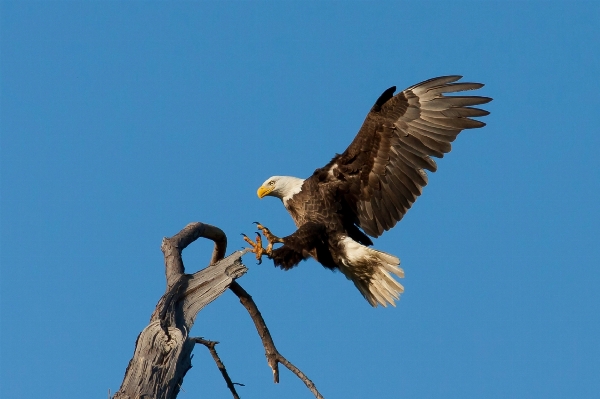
[339, 237, 404, 307]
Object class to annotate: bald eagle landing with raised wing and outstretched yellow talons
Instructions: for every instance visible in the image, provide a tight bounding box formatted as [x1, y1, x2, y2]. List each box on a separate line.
[244, 76, 492, 307]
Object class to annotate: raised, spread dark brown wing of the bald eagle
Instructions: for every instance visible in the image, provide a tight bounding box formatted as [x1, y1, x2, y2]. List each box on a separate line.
[314, 76, 492, 237]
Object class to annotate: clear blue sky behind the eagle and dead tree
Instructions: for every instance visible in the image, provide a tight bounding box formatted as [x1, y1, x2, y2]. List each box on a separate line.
[0, 2, 600, 399]
